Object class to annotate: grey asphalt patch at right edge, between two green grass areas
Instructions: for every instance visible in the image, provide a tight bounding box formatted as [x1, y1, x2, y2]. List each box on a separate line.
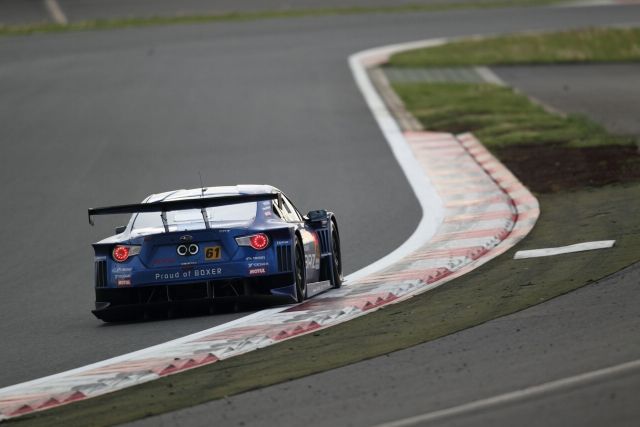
[492, 64, 640, 135]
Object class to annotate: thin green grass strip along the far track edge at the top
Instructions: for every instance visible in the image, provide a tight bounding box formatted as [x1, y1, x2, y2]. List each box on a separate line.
[0, 0, 562, 36]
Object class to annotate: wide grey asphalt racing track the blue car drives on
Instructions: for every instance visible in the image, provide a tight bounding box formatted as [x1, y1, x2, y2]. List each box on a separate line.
[0, 0, 640, 398]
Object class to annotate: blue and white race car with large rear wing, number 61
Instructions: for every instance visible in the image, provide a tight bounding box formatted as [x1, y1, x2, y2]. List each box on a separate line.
[89, 185, 342, 322]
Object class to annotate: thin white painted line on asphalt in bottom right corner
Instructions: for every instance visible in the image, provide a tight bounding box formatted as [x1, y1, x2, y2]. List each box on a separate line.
[376, 359, 640, 427]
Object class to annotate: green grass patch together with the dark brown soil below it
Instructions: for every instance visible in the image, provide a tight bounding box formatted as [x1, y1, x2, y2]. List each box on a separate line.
[393, 83, 640, 193]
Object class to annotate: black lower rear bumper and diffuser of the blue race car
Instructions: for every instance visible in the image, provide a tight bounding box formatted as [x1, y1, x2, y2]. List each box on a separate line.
[92, 273, 295, 321]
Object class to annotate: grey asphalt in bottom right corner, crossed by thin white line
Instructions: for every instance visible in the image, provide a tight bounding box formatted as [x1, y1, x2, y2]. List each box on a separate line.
[130, 264, 640, 427]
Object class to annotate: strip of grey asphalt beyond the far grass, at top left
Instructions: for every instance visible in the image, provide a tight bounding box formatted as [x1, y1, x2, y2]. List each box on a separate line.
[0, 0, 517, 25]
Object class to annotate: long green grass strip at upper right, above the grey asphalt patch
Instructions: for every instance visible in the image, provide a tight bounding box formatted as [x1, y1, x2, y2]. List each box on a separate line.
[389, 28, 640, 67]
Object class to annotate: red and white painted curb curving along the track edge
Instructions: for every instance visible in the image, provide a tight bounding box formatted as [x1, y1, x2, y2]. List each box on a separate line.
[0, 38, 539, 419]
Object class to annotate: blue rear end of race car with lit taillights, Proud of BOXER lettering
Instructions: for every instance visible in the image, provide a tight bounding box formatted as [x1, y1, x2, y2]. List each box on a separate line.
[93, 197, 294, 321]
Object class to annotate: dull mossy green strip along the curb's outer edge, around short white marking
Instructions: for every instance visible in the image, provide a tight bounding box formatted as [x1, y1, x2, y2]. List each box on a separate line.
[13, 184, 640, 426]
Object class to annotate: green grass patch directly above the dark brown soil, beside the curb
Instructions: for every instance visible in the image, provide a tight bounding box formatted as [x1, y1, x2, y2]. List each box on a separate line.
[393, 83, 635, 148]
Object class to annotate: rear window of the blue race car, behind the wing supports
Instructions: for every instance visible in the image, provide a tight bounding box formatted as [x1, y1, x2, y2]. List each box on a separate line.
[132, 202, 257, 234]
